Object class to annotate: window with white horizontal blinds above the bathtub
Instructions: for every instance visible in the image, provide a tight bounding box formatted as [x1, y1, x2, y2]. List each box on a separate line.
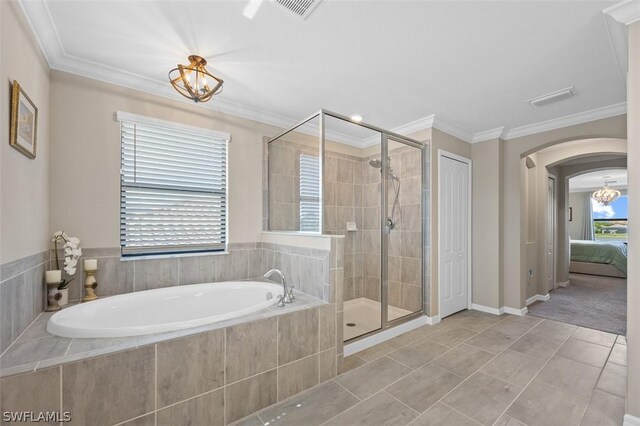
[118, 112, 229, 256]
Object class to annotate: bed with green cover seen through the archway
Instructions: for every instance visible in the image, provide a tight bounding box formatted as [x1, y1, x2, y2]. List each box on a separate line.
[569, 240, 627, 278]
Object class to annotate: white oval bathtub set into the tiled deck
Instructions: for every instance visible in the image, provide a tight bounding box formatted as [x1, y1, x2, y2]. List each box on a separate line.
[47, 281, 282, 338]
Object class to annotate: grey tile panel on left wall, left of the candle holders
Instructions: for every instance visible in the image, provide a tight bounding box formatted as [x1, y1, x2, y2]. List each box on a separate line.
[0, 251, 48, 353]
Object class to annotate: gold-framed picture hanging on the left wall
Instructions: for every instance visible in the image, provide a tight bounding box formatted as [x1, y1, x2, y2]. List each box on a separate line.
[9, 80, 38, 159]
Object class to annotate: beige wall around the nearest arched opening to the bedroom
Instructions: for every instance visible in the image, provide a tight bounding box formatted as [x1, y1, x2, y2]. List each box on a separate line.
[500, 115, 626, 309]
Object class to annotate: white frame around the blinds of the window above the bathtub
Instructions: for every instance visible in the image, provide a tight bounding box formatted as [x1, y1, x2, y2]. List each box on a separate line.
[116, 111, 231, 260]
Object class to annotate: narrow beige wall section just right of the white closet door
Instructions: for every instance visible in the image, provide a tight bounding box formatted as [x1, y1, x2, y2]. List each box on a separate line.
[471, 139, 504, 309]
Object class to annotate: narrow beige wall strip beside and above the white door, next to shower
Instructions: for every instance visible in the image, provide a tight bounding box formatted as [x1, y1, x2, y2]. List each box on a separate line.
[429, 129, 473, 316]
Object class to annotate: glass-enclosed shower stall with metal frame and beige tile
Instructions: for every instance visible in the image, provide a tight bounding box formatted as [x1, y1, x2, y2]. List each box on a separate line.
[264, 110, 430, 341]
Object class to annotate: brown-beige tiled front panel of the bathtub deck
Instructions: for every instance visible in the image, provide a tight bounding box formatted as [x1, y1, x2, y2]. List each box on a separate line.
[0, 305, 336, 425]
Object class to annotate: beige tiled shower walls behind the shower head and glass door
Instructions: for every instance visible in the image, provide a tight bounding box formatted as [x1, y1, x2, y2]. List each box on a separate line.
[324, 147, 428, 312]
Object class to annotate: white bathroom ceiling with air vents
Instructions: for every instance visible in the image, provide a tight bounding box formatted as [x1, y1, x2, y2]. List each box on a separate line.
[20, 0, 626, 144]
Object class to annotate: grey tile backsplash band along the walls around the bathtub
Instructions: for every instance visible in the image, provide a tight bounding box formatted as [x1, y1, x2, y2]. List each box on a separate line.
[0, 242, 344, 353]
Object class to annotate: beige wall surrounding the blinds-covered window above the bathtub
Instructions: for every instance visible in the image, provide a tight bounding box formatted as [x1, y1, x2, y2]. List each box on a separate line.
[51, 72, 279, 247]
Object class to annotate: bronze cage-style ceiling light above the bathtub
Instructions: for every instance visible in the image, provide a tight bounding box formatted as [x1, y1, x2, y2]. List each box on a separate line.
[169, 55, 224, 103]
